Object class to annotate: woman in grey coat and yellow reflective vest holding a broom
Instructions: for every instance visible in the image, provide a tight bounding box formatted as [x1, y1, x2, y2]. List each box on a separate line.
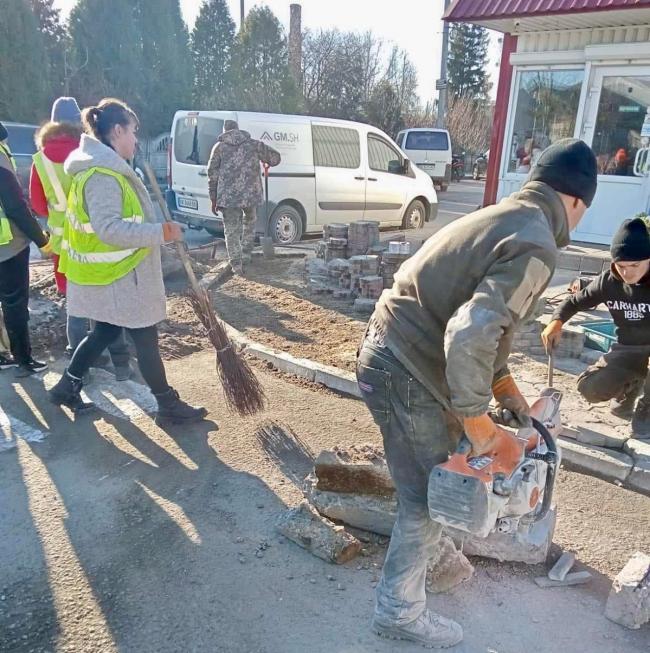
[50, 98, 206, 424]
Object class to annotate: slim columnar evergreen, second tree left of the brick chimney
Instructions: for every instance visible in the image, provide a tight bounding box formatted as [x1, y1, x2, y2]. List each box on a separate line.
[191, 0, 235, 109]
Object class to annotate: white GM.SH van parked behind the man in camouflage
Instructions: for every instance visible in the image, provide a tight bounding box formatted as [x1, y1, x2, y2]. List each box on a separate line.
[167, 111, 438, 244]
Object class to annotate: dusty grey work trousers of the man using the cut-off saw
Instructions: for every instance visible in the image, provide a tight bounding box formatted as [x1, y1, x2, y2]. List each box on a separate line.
[357, 339, 461, 625]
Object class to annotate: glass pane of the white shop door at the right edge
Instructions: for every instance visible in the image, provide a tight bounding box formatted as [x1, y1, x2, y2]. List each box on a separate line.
[592, 76, 650, 177]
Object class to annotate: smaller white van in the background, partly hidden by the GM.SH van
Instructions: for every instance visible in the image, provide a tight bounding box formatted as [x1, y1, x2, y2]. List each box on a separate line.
[397, 127, 451, 191]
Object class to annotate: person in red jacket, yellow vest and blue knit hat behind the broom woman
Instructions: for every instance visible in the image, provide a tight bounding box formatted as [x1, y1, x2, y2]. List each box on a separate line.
[29, 97, 133, 381]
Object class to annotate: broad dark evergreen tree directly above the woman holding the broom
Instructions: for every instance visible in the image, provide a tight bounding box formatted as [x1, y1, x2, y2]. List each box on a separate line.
[69, 0, 145, 115]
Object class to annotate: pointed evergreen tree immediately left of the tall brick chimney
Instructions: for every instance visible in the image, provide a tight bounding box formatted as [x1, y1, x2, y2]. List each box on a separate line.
[234, 7, 301, 113]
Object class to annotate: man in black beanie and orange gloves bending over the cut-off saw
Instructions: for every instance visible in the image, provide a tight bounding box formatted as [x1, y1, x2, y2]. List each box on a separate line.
[357, 139, 596, 648]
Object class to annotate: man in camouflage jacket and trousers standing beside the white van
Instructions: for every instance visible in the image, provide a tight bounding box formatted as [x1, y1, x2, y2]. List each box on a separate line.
[208, 120, 281, 274]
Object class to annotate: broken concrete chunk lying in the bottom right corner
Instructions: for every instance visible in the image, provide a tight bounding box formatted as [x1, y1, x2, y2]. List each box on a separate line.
[605, 551, 650, 630]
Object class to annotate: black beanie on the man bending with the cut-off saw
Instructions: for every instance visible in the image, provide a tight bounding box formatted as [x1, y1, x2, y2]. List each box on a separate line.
[528, 138, 598, 206]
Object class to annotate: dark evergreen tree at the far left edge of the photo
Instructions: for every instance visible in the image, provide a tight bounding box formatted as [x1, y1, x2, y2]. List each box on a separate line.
[0, 0, 48, 122]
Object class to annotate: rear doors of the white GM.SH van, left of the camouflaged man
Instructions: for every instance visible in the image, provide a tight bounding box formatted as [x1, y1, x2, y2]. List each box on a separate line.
[172, 111, 235, 216]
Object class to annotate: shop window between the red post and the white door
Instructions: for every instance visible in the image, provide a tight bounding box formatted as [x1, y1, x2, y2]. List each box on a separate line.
[508, 70, 584, 174]
